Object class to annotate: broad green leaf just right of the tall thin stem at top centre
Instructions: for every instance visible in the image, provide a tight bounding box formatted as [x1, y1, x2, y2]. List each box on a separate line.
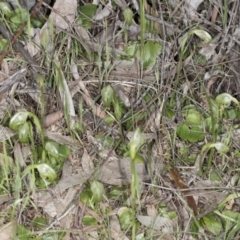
[140, 40, 162, 70]
